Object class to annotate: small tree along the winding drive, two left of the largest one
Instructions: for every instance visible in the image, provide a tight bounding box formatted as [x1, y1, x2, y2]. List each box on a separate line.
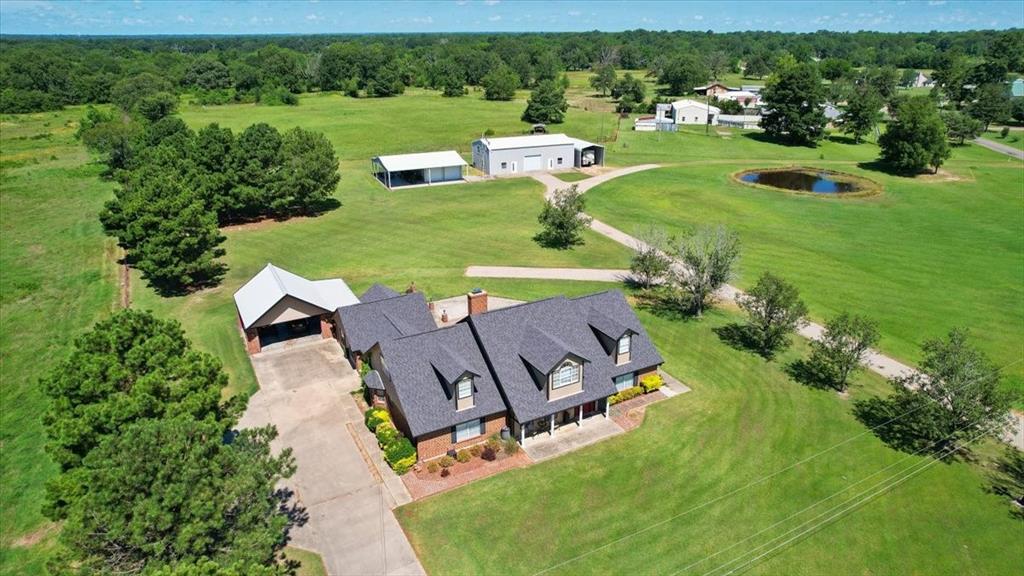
[738, 272, 807, 358]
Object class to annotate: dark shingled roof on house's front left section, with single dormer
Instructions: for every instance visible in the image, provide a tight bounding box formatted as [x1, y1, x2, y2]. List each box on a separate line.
[381, 324, 505, 437]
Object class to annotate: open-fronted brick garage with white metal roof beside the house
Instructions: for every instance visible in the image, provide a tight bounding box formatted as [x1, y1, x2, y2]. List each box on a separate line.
[234, 263, 359, 354]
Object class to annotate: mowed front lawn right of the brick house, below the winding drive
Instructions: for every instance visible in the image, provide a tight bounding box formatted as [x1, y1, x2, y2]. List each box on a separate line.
[396, 311, 1024, 576]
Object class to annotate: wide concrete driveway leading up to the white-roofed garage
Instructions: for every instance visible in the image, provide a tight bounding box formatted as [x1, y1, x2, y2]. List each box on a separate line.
[241, 340, 424, 576]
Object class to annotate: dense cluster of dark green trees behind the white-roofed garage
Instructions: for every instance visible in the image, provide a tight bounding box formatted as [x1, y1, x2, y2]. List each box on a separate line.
[78, 83, 340, 294]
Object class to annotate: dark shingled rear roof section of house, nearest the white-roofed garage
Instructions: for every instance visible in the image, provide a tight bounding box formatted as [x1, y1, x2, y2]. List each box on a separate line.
[338, 292, 437, 353]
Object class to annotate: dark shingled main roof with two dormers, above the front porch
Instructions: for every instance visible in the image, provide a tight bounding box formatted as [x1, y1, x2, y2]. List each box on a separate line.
[464, 290, 664, 422]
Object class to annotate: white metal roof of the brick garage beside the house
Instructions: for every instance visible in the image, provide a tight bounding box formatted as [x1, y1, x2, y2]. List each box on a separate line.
[234, 263, 359, 328]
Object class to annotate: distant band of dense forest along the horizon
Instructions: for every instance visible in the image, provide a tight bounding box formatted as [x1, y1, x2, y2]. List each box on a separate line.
[0, 30, 1024, 113]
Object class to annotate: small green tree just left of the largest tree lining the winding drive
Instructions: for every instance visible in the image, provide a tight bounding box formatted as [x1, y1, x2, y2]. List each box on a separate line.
[809, 313, 879, 392]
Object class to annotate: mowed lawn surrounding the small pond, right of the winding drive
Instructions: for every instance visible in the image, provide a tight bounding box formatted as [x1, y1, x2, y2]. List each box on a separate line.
[587, 128, 1024, 393]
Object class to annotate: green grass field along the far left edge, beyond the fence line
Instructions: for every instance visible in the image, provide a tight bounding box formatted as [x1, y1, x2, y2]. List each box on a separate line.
[0, 111, 117, 574]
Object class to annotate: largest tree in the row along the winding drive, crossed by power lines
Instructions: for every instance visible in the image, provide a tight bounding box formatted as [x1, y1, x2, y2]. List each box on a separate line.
[865, 329, 1013, 454]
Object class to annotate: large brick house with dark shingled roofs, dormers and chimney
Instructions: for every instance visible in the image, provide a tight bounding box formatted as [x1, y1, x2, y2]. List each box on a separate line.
[337, 287, 663, 460]
